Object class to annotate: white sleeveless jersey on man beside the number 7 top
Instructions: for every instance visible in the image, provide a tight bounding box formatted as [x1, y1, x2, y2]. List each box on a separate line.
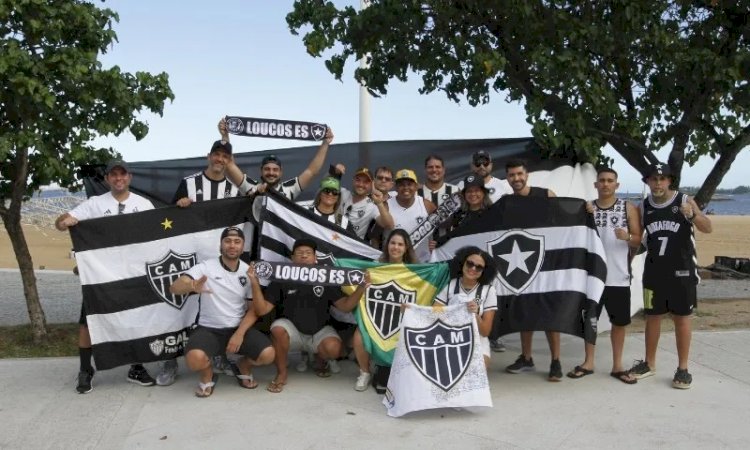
[593, 198, 630, 286]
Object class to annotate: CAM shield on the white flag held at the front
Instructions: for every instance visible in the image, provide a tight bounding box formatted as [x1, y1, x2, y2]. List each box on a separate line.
[403, 320, 474, 391]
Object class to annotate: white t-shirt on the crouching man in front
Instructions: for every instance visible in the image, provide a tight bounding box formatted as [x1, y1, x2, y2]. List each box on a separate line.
[185, 258, 252, 328]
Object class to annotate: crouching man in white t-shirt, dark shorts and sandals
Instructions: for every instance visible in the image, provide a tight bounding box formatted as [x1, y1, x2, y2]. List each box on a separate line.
[169, 227, 275, 398]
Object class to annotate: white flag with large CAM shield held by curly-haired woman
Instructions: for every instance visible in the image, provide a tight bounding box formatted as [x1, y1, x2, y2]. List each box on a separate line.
[383, 304, 492, 417]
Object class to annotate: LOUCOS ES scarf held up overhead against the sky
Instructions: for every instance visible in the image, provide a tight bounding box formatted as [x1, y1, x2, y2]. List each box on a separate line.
[226, 116, 328, 141]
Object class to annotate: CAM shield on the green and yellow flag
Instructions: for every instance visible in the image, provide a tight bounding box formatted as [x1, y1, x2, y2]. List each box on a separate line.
[365, 280, 417, 340]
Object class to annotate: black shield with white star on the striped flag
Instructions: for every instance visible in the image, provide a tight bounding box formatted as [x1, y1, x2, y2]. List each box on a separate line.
[487, 230, 544, 294]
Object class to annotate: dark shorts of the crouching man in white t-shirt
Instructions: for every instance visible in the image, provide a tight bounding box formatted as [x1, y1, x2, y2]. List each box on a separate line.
[185, 325, 271, 360]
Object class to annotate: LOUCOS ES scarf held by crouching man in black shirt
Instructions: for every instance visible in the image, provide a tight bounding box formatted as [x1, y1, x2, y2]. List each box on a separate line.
[255, 261, 365, 286]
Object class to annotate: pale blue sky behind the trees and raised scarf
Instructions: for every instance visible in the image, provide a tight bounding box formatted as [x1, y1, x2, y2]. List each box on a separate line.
[96, 0, 750, 192]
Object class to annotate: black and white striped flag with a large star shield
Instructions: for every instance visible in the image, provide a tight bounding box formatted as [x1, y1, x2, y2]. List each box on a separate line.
[432, 195, 607, 343]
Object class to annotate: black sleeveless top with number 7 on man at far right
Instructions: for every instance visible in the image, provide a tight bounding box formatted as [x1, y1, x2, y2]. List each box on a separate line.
[641, 192, 698, 287]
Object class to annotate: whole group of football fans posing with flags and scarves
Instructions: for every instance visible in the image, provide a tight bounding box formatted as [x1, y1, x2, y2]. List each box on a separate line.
[55, 121, 711, 397]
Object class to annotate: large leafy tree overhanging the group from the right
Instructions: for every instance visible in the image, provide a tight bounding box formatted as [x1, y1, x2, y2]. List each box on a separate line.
[287, 0, 750, 207]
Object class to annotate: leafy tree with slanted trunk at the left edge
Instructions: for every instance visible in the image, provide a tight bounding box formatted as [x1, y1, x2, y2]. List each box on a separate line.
[0, 0, 174, 342]
